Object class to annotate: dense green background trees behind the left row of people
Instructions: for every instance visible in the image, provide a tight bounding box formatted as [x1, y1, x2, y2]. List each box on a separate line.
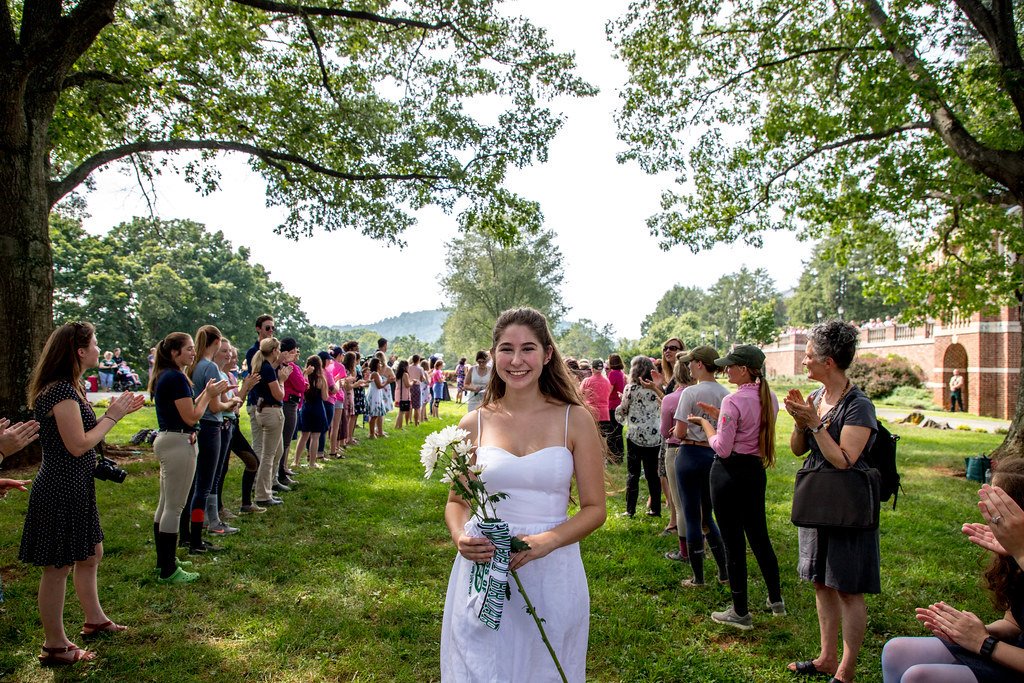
[52, 216, 315, 364]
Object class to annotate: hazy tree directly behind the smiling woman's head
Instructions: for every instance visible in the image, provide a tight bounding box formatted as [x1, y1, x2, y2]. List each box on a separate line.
[441, 230, 565, 355]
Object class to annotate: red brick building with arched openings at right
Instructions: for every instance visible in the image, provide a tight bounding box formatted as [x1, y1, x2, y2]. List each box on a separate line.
[762, 306, 1021, 420]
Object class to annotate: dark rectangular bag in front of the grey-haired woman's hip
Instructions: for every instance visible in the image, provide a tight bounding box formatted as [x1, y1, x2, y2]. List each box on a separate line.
[791, 463, 882, 530]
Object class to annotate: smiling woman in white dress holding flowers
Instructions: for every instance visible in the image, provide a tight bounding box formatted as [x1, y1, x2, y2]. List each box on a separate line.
[440, 308, 605, 683]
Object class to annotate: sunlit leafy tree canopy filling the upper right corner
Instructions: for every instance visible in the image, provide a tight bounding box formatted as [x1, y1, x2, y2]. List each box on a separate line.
[609, 0, 1024, 455]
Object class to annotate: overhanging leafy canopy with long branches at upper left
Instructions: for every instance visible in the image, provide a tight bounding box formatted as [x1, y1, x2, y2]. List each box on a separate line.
[46, 0, 593, 240]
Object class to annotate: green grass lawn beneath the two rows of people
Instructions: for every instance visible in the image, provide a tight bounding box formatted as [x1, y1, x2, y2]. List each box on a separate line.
[0, 404, 1001, 683]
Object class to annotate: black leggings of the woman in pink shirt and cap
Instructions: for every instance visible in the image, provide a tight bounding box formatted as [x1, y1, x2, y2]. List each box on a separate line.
[711, 454, 782, 616]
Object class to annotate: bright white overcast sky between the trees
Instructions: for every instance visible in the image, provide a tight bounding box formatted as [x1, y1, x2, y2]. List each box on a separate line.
[79, 0, 809, 338]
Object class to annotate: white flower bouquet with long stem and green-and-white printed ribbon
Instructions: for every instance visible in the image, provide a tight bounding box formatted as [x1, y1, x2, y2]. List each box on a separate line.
[420, 425, 566, 681]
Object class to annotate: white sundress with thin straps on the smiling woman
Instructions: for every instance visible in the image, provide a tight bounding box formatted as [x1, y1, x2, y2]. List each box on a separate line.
[440, 407, 590, 683]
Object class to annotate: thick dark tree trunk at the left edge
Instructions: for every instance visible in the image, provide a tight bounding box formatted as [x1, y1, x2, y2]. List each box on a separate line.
[0, 92, 53, 466]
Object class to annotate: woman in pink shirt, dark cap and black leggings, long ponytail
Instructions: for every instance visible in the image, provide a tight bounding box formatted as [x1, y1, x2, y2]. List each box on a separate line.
[687, 344, 785, 631]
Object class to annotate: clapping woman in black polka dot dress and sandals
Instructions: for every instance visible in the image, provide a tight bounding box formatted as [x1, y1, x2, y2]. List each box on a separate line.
[18, 323, 143, 666]
